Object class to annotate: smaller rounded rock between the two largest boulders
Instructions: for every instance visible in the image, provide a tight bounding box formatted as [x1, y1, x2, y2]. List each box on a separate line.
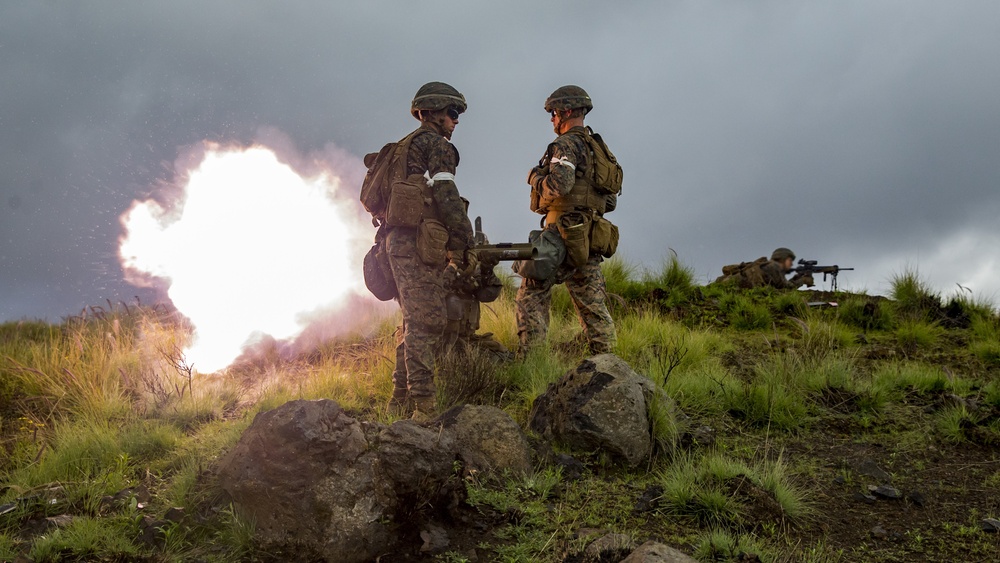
[435, 405, 531, 475]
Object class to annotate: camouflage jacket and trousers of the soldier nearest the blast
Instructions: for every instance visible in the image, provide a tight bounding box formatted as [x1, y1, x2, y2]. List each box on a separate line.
[386, 123, 472, 401]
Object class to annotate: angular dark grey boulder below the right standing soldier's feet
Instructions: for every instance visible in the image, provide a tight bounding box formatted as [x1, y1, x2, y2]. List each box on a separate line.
[529, 354, 674, 466]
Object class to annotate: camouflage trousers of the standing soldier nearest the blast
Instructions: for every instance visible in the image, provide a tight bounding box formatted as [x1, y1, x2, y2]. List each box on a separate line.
[386, 229, 447, 398]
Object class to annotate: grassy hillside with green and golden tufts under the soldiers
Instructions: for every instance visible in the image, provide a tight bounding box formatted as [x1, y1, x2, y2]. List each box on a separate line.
[0, 260, 1000, 561]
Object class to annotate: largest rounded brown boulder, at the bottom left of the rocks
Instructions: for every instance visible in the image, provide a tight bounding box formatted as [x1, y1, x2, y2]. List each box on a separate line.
[218, 400, 398, 562]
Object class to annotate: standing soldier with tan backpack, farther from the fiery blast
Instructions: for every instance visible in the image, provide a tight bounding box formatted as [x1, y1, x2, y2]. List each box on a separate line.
[516, 86, 620, 354]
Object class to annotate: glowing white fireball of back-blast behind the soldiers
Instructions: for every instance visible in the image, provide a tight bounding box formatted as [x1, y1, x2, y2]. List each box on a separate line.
[119, 144, 380, 373]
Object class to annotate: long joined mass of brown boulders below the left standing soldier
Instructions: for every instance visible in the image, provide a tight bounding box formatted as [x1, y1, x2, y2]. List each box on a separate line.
[216, 400, 530, 563]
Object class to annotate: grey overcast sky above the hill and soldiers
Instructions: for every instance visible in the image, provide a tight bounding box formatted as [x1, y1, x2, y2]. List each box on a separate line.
[0, 0, 1000, 321]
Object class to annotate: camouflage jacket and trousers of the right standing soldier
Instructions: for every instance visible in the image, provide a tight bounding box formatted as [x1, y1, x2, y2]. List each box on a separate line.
[516, 127, 617, 354]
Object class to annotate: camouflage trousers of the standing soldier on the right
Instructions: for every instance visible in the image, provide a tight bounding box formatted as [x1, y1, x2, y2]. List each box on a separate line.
[515, 256, 618, 354]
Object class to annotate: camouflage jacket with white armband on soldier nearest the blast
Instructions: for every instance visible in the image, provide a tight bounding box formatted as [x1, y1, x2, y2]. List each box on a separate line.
[406, 123, 473, 250]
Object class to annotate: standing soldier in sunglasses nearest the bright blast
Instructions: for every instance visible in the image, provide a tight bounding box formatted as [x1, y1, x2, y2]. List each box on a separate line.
[386, 82, 475, 418]
